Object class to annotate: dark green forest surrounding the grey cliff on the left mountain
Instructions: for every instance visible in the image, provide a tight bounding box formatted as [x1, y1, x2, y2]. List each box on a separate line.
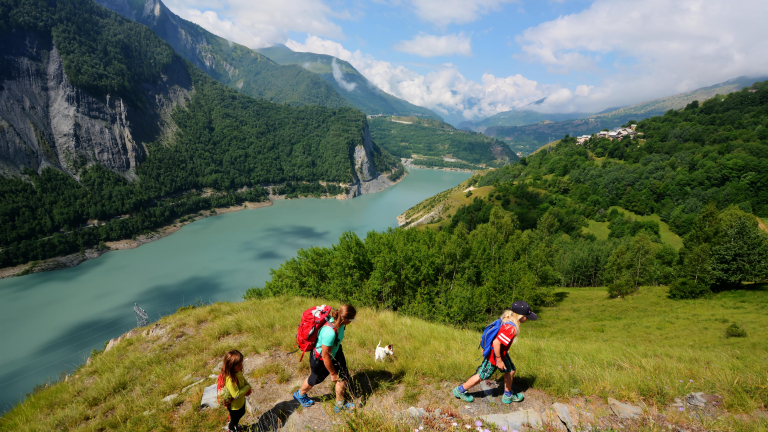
[0, 0, 402, 267]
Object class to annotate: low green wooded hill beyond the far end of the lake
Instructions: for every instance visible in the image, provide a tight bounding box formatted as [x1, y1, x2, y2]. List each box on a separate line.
[370, 117, 517, 168]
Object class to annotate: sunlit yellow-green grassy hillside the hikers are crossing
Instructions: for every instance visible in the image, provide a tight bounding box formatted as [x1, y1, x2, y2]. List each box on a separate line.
[0, 287, 768, 432]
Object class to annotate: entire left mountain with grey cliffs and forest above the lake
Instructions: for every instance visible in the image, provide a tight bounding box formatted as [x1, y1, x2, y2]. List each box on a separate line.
[0, 0, 399, 267]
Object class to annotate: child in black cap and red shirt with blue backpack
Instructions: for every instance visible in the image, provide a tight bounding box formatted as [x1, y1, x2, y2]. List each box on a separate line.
[452, 301, 538, 404]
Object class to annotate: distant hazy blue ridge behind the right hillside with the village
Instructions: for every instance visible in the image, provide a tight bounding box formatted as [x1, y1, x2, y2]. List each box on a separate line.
[482, 77, 768, 156]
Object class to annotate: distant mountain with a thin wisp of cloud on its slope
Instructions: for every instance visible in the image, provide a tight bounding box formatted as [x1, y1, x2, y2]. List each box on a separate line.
[258, 45, 440, 119]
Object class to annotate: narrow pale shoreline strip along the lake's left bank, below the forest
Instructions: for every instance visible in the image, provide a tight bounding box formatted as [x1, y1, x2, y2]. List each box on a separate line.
[0, 167, 412, 279]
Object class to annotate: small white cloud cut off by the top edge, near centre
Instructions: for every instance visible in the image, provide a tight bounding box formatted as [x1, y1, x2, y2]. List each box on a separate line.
[411, 0, 517, 27]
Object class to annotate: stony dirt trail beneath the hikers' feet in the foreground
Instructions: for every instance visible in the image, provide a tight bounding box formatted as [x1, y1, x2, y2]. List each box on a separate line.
[200, 353, 725, 432]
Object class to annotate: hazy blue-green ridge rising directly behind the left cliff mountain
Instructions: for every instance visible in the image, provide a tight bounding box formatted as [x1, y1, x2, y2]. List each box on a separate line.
[92, 0, 352, 108]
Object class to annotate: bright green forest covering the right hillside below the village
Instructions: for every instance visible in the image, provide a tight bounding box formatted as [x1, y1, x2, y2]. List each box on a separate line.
[246, 83, 768, 326]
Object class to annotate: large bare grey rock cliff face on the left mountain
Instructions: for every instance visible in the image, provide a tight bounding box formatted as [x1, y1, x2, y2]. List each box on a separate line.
[0, 31, 192, 178]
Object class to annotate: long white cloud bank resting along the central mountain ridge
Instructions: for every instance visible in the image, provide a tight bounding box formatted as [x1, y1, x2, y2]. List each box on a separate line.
[286, 35, 557, 119]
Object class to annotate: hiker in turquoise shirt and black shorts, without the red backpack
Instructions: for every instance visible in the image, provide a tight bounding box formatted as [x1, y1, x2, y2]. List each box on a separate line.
[293, 304, 357, 413]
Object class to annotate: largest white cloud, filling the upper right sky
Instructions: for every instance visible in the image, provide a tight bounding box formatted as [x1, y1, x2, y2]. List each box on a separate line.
[517, 0, 768, 111]
